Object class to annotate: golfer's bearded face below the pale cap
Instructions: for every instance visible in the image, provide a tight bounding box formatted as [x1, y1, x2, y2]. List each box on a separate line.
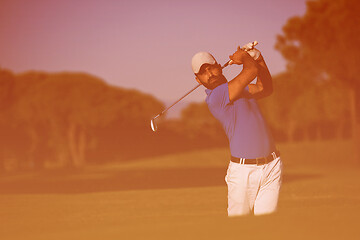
[196, 63, 227, 89]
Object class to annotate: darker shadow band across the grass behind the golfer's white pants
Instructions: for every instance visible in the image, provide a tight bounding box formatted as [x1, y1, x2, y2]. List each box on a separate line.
[0, 168, 320, 194]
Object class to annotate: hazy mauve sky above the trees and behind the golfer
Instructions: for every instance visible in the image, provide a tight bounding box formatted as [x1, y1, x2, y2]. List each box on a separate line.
[0, 0, 306, 106]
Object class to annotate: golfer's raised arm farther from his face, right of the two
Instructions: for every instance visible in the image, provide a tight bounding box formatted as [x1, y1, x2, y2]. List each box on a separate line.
[246, 55, 273, 99]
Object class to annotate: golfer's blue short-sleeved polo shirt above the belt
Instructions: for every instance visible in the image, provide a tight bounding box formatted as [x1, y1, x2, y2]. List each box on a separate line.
[205, 83, 275, 158]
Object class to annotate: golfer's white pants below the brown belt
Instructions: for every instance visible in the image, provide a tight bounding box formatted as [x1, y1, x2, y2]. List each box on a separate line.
[225, 157, 282, 217]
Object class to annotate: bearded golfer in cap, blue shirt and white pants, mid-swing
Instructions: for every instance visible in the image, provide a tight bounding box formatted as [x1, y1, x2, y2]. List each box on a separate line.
[192, 45, 282, 216]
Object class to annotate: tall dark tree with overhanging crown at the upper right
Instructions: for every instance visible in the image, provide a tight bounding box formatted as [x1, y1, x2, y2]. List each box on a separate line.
[276, 0, 360, 157]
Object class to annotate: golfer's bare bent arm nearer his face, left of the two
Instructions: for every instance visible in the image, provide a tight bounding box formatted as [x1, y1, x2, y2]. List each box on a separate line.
[228, 48, 259, 102]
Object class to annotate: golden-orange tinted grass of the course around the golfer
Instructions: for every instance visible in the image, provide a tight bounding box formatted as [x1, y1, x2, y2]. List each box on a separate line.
[0, 142, 360, 240]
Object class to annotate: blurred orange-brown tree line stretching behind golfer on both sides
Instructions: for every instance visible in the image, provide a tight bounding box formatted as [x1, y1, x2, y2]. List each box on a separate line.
[0, 66, 351, 170]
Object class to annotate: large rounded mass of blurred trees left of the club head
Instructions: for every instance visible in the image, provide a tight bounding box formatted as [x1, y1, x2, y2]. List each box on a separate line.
[0, 70, 163, 171]
